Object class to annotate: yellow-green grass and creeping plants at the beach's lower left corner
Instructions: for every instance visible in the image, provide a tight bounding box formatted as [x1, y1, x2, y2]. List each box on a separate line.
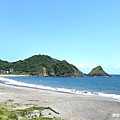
[0, 99, 62, 120]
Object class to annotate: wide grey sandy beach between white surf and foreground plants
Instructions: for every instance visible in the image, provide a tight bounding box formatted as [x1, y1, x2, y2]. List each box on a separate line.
[0, 83, 120, 120]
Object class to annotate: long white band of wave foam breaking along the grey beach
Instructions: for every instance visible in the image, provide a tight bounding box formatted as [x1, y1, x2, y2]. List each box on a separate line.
[0, 77, 120, 100]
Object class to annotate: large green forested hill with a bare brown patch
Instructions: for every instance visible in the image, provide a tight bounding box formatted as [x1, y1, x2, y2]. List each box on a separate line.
[0, 54, 84, 76]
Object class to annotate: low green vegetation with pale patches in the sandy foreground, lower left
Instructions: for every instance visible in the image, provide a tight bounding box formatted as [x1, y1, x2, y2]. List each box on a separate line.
[0, 100, 62, 120]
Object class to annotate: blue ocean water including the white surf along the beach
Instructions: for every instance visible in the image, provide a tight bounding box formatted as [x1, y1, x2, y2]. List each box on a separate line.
[1, 75, 120, 100]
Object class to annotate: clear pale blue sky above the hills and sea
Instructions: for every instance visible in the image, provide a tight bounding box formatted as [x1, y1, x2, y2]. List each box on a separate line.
[0, 0, 120, 74]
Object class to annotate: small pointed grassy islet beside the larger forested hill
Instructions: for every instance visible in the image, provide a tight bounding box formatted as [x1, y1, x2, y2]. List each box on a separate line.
[87, 66, 110, 77]
